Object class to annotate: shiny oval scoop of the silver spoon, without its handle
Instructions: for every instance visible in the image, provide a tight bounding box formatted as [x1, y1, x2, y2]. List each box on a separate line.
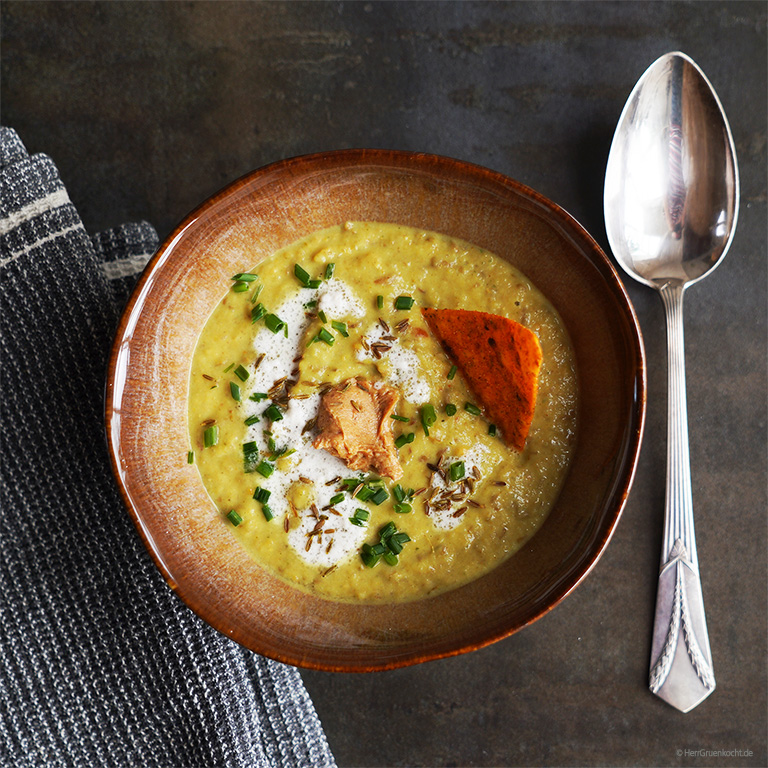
[605, 52, 739, 288]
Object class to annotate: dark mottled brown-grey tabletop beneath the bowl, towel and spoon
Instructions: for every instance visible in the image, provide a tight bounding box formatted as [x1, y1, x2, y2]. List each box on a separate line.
[1, 0, 768, 766]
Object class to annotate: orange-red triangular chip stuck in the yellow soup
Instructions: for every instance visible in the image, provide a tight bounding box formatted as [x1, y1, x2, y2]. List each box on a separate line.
[421, 309, 541, 451]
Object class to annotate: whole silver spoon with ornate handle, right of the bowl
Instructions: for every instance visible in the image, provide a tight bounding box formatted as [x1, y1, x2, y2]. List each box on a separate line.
[604, 53, 739, 712]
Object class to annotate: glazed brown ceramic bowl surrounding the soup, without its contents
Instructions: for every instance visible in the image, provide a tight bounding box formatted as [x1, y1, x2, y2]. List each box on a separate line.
[106, 150, 645, 671]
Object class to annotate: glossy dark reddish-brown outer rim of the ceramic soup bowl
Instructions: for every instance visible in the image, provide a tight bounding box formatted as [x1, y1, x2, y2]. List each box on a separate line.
[104, 149, 647, 672]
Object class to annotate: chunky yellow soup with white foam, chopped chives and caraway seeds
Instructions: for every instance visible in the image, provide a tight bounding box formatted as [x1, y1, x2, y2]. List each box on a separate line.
[189, 222, 577, 603]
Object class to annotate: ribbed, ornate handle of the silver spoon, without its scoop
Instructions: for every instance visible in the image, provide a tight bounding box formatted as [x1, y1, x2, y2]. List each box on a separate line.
[649, 284, 715, 712]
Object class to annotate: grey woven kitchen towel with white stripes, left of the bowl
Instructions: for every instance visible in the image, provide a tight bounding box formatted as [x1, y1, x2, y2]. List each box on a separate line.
[0, 128, 334, 768]
